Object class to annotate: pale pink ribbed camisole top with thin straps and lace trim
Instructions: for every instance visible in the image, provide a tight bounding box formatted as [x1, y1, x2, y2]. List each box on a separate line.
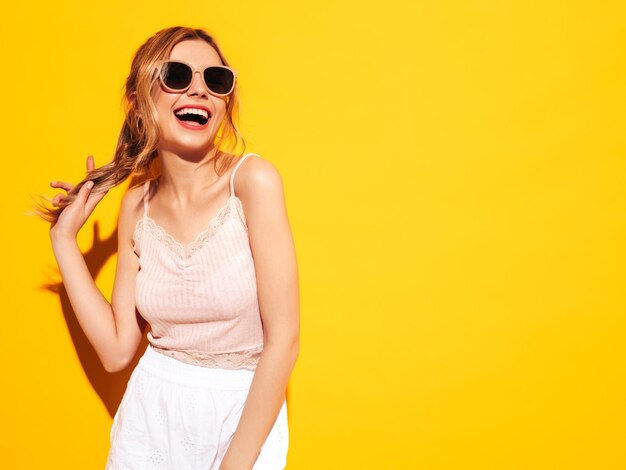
[133, 154, 263, 370]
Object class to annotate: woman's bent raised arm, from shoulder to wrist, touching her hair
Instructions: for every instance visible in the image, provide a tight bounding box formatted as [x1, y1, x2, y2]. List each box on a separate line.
[50, 178, 146, 372]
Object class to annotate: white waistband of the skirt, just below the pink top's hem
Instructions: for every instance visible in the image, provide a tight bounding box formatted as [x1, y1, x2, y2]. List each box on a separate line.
[137, 344, 254, 390]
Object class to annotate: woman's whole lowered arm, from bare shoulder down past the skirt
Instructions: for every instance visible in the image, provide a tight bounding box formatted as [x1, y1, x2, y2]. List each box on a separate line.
[220, 155, 300, 470]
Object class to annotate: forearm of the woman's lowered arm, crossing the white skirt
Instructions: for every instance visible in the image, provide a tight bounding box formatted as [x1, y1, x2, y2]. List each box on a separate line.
[224, 344, 298, 469]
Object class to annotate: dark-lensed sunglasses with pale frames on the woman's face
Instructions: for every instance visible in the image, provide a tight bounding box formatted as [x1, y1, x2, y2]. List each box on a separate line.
[157, 60, 237, 96]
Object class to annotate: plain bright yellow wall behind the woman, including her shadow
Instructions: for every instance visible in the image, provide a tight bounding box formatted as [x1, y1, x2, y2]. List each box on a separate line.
[0, 0, 626, 470]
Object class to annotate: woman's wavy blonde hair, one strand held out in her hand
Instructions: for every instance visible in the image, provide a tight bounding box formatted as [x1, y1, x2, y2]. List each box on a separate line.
[33, 26, 246, 223]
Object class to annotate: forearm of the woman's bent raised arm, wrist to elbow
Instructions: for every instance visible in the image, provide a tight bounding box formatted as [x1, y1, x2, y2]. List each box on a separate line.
[51, 237, 118, 370]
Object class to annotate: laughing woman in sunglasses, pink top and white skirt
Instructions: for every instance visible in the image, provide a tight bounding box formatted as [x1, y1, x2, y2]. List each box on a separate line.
[40, 27, 299, 470]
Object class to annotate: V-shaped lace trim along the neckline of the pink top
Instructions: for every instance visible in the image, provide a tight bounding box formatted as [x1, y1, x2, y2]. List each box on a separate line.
[133, 195, 248, 259]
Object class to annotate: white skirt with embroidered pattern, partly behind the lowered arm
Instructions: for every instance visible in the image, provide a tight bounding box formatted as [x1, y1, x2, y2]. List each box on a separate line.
[105, 345, 289, 470]
